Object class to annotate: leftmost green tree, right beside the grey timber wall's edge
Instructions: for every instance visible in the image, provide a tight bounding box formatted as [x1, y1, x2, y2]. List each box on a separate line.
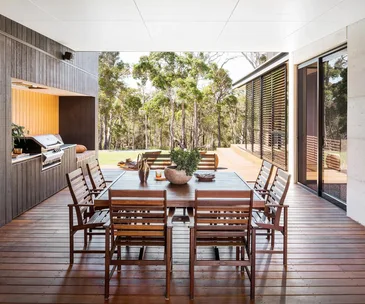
[99, 52, 129, 149]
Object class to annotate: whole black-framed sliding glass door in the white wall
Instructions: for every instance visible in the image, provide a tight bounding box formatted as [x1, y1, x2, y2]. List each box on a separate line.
[298, 49, 347, 205]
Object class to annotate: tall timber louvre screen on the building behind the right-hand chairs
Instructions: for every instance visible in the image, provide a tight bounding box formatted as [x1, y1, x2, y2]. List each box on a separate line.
[240, 64, 288, 170]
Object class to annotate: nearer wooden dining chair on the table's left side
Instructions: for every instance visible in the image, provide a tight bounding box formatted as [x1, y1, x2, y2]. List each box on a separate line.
[66, 168, 109, 264]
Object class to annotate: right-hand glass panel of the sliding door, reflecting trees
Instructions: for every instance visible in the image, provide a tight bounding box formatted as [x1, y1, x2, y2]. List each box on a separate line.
[322, 50, 347, 202]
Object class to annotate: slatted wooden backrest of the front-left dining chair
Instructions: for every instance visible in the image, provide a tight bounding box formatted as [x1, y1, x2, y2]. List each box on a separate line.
[109, 190, 167, 242]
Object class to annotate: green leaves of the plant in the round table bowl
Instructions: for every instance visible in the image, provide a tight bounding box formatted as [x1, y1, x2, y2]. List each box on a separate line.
[171, 148, 200, 176]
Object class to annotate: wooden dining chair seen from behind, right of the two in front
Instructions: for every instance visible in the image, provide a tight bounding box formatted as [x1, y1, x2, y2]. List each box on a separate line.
[189, 190, 256, 299]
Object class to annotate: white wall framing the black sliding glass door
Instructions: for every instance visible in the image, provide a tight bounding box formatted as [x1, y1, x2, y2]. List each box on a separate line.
[289, 19, 365, 225]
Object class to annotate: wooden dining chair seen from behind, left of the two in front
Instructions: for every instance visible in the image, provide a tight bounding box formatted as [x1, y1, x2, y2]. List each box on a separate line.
[104, 189, 172, 299]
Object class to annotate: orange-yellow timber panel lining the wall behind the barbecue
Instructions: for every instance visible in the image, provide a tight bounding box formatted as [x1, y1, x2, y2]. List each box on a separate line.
[11, 88, 59, 135]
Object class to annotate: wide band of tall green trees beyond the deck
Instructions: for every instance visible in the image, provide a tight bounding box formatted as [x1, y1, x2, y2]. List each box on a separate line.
[99, 52, 245, 150]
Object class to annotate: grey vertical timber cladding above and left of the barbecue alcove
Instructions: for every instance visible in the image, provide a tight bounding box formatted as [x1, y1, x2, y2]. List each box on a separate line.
[0, 15, 98, 226]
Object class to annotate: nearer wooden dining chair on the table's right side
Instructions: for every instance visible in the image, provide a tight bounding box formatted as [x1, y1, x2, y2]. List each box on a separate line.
[253, 168, 290, 265]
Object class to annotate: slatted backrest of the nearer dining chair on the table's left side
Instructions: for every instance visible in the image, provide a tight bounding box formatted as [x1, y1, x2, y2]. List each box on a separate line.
[66, 168, 94, 225]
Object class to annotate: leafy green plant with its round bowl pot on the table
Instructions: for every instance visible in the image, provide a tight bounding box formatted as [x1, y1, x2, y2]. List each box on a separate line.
[164, 148, 200, 185]
